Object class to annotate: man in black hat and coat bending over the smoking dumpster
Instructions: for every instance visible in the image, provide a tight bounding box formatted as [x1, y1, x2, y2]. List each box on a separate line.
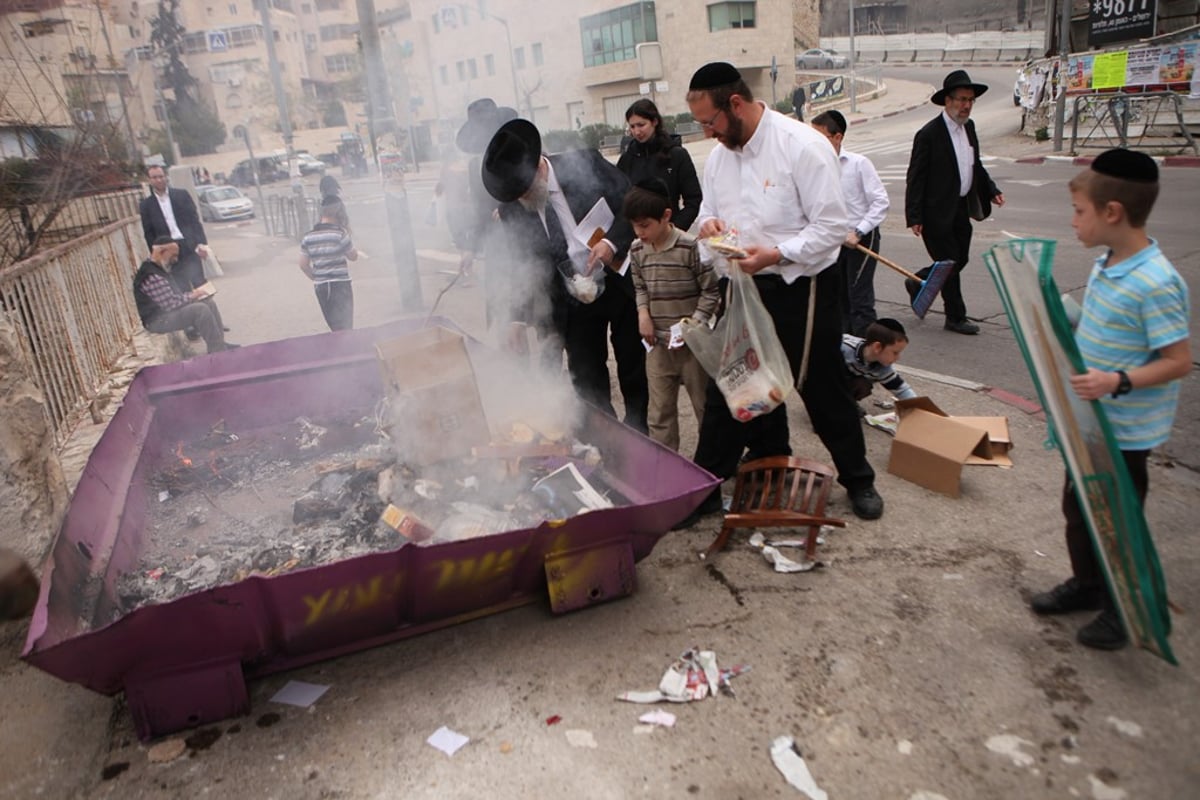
[481, 119, 649, 433]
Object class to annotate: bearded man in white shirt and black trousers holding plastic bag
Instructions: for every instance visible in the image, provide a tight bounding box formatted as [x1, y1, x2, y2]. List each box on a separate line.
[688, 62, 883, 519]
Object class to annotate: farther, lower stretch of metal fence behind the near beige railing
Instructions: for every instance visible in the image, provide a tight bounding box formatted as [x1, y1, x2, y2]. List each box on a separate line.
[0, 187, 143, 270]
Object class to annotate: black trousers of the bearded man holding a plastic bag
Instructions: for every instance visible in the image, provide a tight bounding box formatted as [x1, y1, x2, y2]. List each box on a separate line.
[695, 267, 875, 491]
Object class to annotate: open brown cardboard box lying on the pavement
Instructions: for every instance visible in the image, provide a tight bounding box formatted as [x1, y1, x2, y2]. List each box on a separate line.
[888, 397, 1013, 498]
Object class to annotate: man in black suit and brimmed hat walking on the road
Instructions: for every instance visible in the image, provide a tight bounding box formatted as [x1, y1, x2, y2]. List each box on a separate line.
[905, 70, 1004, 336]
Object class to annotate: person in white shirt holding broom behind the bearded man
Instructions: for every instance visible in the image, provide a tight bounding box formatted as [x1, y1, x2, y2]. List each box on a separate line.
[812, 108, 888, 337]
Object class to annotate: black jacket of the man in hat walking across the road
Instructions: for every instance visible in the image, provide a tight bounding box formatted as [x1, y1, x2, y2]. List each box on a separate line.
[904, 114, 1000, 228]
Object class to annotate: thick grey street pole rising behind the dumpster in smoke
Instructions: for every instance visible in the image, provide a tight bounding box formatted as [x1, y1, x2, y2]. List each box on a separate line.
[355, 0, 425, 312]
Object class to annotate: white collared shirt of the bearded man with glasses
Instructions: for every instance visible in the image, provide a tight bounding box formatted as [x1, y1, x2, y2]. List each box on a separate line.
[697, 103, 850, 283]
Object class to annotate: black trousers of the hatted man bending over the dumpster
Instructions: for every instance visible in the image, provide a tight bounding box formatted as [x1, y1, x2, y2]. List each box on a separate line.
[562, 272, 650, 433]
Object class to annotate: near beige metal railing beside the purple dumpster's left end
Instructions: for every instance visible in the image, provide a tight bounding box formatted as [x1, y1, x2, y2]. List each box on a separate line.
[0, 216, 146, 446]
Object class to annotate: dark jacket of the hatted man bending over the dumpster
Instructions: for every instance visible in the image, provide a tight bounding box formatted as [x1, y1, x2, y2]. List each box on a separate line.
[499, 150, 634, 325]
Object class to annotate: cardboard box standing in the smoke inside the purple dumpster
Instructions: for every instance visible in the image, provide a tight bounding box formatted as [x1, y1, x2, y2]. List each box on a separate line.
[376, 327, 491, 464]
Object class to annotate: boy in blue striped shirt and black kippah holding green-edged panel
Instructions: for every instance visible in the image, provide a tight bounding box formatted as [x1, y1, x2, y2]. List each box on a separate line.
[1030, 150, 1192, 650]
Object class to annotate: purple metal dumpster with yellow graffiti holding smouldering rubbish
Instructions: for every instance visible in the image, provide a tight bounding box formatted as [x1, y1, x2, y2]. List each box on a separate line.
[23, 320, 718, 739]
